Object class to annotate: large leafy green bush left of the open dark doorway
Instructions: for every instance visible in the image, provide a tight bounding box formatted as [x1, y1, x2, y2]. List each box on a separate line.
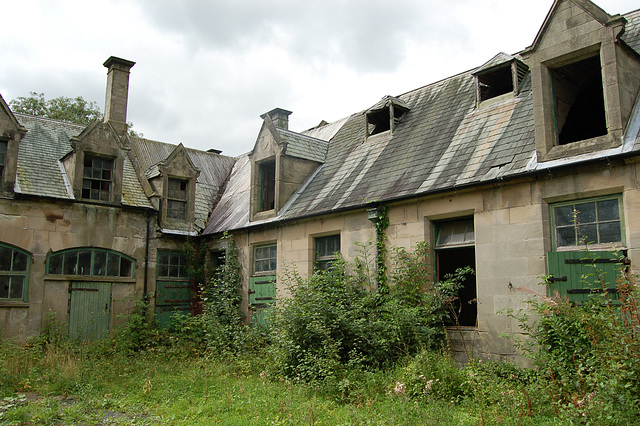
[272, 241, 444, 382]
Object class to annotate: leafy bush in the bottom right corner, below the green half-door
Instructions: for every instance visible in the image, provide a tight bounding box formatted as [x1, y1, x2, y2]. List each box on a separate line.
[515, 268, 640, 424]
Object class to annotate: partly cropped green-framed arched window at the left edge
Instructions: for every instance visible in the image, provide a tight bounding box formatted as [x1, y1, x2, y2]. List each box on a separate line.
[0, 243, 31, 302]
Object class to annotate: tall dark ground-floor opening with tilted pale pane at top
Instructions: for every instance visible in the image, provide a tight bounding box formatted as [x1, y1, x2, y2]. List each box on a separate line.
[435, 218, 478, 327]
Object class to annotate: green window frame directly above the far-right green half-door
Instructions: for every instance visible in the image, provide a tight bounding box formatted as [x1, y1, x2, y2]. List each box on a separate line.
[549, 194, 626, 251]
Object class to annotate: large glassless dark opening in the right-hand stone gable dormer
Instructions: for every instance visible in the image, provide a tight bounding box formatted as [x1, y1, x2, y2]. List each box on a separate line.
[551, 55, 607, 145]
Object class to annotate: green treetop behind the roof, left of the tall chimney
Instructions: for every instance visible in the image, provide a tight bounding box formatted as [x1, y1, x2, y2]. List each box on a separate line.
[9, 92, 102, 124]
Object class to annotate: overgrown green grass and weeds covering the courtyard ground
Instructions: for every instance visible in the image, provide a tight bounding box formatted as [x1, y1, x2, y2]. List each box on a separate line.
[0, 341, 558, 425]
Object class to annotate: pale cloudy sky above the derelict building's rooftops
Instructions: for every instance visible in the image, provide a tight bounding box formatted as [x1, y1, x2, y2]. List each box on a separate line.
[0, 0, 639, 156]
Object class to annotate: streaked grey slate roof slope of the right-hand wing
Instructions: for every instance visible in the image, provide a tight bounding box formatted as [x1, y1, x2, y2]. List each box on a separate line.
[204, 5, 640, 234]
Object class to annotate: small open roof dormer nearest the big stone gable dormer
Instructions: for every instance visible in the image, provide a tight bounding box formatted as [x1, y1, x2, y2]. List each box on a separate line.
[474, 53, 529, 102]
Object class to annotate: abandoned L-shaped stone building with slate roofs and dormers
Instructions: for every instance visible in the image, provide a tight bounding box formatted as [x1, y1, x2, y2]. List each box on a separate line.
[0, 0, 640, 362]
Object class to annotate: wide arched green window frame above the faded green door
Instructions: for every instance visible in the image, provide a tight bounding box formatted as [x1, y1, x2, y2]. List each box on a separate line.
[45, 247, 136, 281]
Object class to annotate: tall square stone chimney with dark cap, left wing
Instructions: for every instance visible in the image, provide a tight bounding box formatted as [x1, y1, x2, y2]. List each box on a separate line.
[103, 56, 135, 135]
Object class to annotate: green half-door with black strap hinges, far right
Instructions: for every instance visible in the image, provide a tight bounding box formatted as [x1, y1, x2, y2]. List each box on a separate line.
[547, 251, 624, 303]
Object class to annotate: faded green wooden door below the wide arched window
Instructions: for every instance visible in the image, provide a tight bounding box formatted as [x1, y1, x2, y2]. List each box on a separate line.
[68, 282, 111, 341]
